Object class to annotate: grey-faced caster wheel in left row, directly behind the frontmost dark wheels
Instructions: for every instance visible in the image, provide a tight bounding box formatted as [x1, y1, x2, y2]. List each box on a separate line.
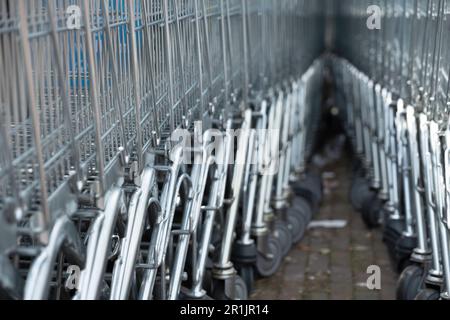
[256, 235, 282, 277]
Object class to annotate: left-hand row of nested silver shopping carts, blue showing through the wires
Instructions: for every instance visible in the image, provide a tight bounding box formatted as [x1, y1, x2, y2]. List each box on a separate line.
[0, 0, 325, 299]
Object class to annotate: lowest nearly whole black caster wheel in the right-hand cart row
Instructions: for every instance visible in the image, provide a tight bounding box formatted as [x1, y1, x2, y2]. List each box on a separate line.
[396, 264, 424, 300]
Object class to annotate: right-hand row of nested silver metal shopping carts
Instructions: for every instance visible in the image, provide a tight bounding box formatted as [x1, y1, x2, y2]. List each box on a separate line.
[331, 0, 450, 300]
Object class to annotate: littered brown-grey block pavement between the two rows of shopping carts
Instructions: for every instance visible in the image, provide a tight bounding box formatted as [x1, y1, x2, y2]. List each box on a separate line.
[251, 156, 397, 300]
